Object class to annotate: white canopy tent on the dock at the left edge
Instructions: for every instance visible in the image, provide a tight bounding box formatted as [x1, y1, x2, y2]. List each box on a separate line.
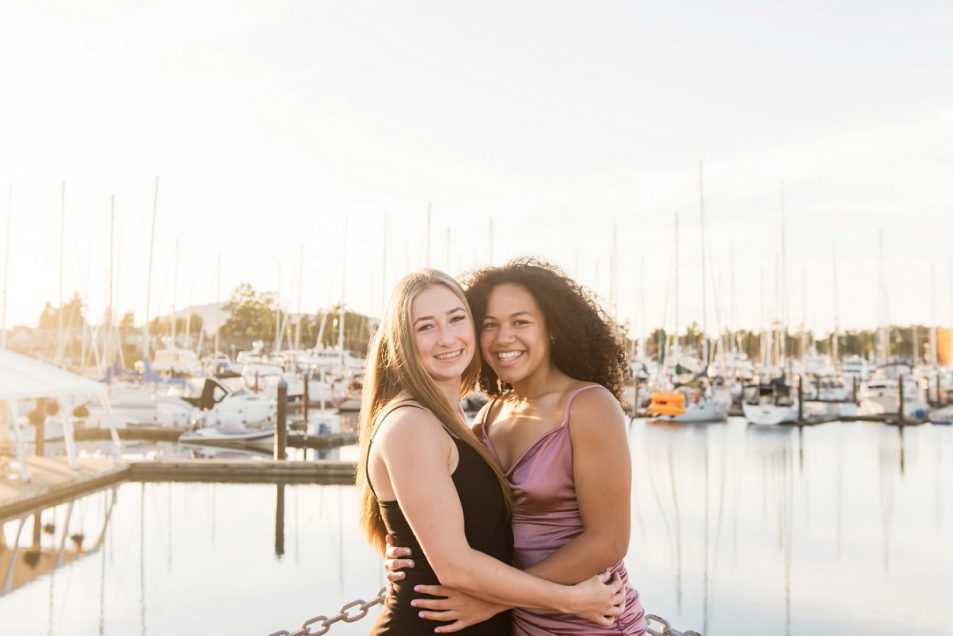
[0, 349, 120, 481]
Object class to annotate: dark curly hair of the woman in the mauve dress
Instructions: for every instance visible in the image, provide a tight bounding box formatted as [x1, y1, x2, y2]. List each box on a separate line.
[463, 258, 629, 402]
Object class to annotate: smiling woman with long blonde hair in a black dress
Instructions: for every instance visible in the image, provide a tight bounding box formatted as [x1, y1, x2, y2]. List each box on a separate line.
[358, 270, 624, 635]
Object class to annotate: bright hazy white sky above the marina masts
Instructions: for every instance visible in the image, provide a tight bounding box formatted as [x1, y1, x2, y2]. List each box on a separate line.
[0, 0, 953, 338]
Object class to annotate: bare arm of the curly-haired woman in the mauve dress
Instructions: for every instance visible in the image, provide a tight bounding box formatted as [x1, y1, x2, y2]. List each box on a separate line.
[526, 389, 632, 584]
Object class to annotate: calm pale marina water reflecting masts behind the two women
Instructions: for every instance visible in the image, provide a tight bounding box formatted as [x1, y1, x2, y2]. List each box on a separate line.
[0, 420, 953, 635]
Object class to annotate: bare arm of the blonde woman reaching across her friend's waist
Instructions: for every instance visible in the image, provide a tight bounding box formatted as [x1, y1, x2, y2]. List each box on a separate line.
[371, 409, 615, 615]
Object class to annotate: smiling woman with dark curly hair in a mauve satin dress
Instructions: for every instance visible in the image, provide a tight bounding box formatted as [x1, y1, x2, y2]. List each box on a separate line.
[388, 259, 645, 636]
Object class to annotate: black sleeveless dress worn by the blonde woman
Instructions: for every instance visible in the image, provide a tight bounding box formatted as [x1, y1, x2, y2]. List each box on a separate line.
[367, 402, 513, 636]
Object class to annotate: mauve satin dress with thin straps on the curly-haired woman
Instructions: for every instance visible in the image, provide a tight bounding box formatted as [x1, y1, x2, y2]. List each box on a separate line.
[481, 384, 645, 636]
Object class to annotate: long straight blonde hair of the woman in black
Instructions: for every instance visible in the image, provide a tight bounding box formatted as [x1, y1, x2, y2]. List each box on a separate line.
[357, 269, 511, 552]
